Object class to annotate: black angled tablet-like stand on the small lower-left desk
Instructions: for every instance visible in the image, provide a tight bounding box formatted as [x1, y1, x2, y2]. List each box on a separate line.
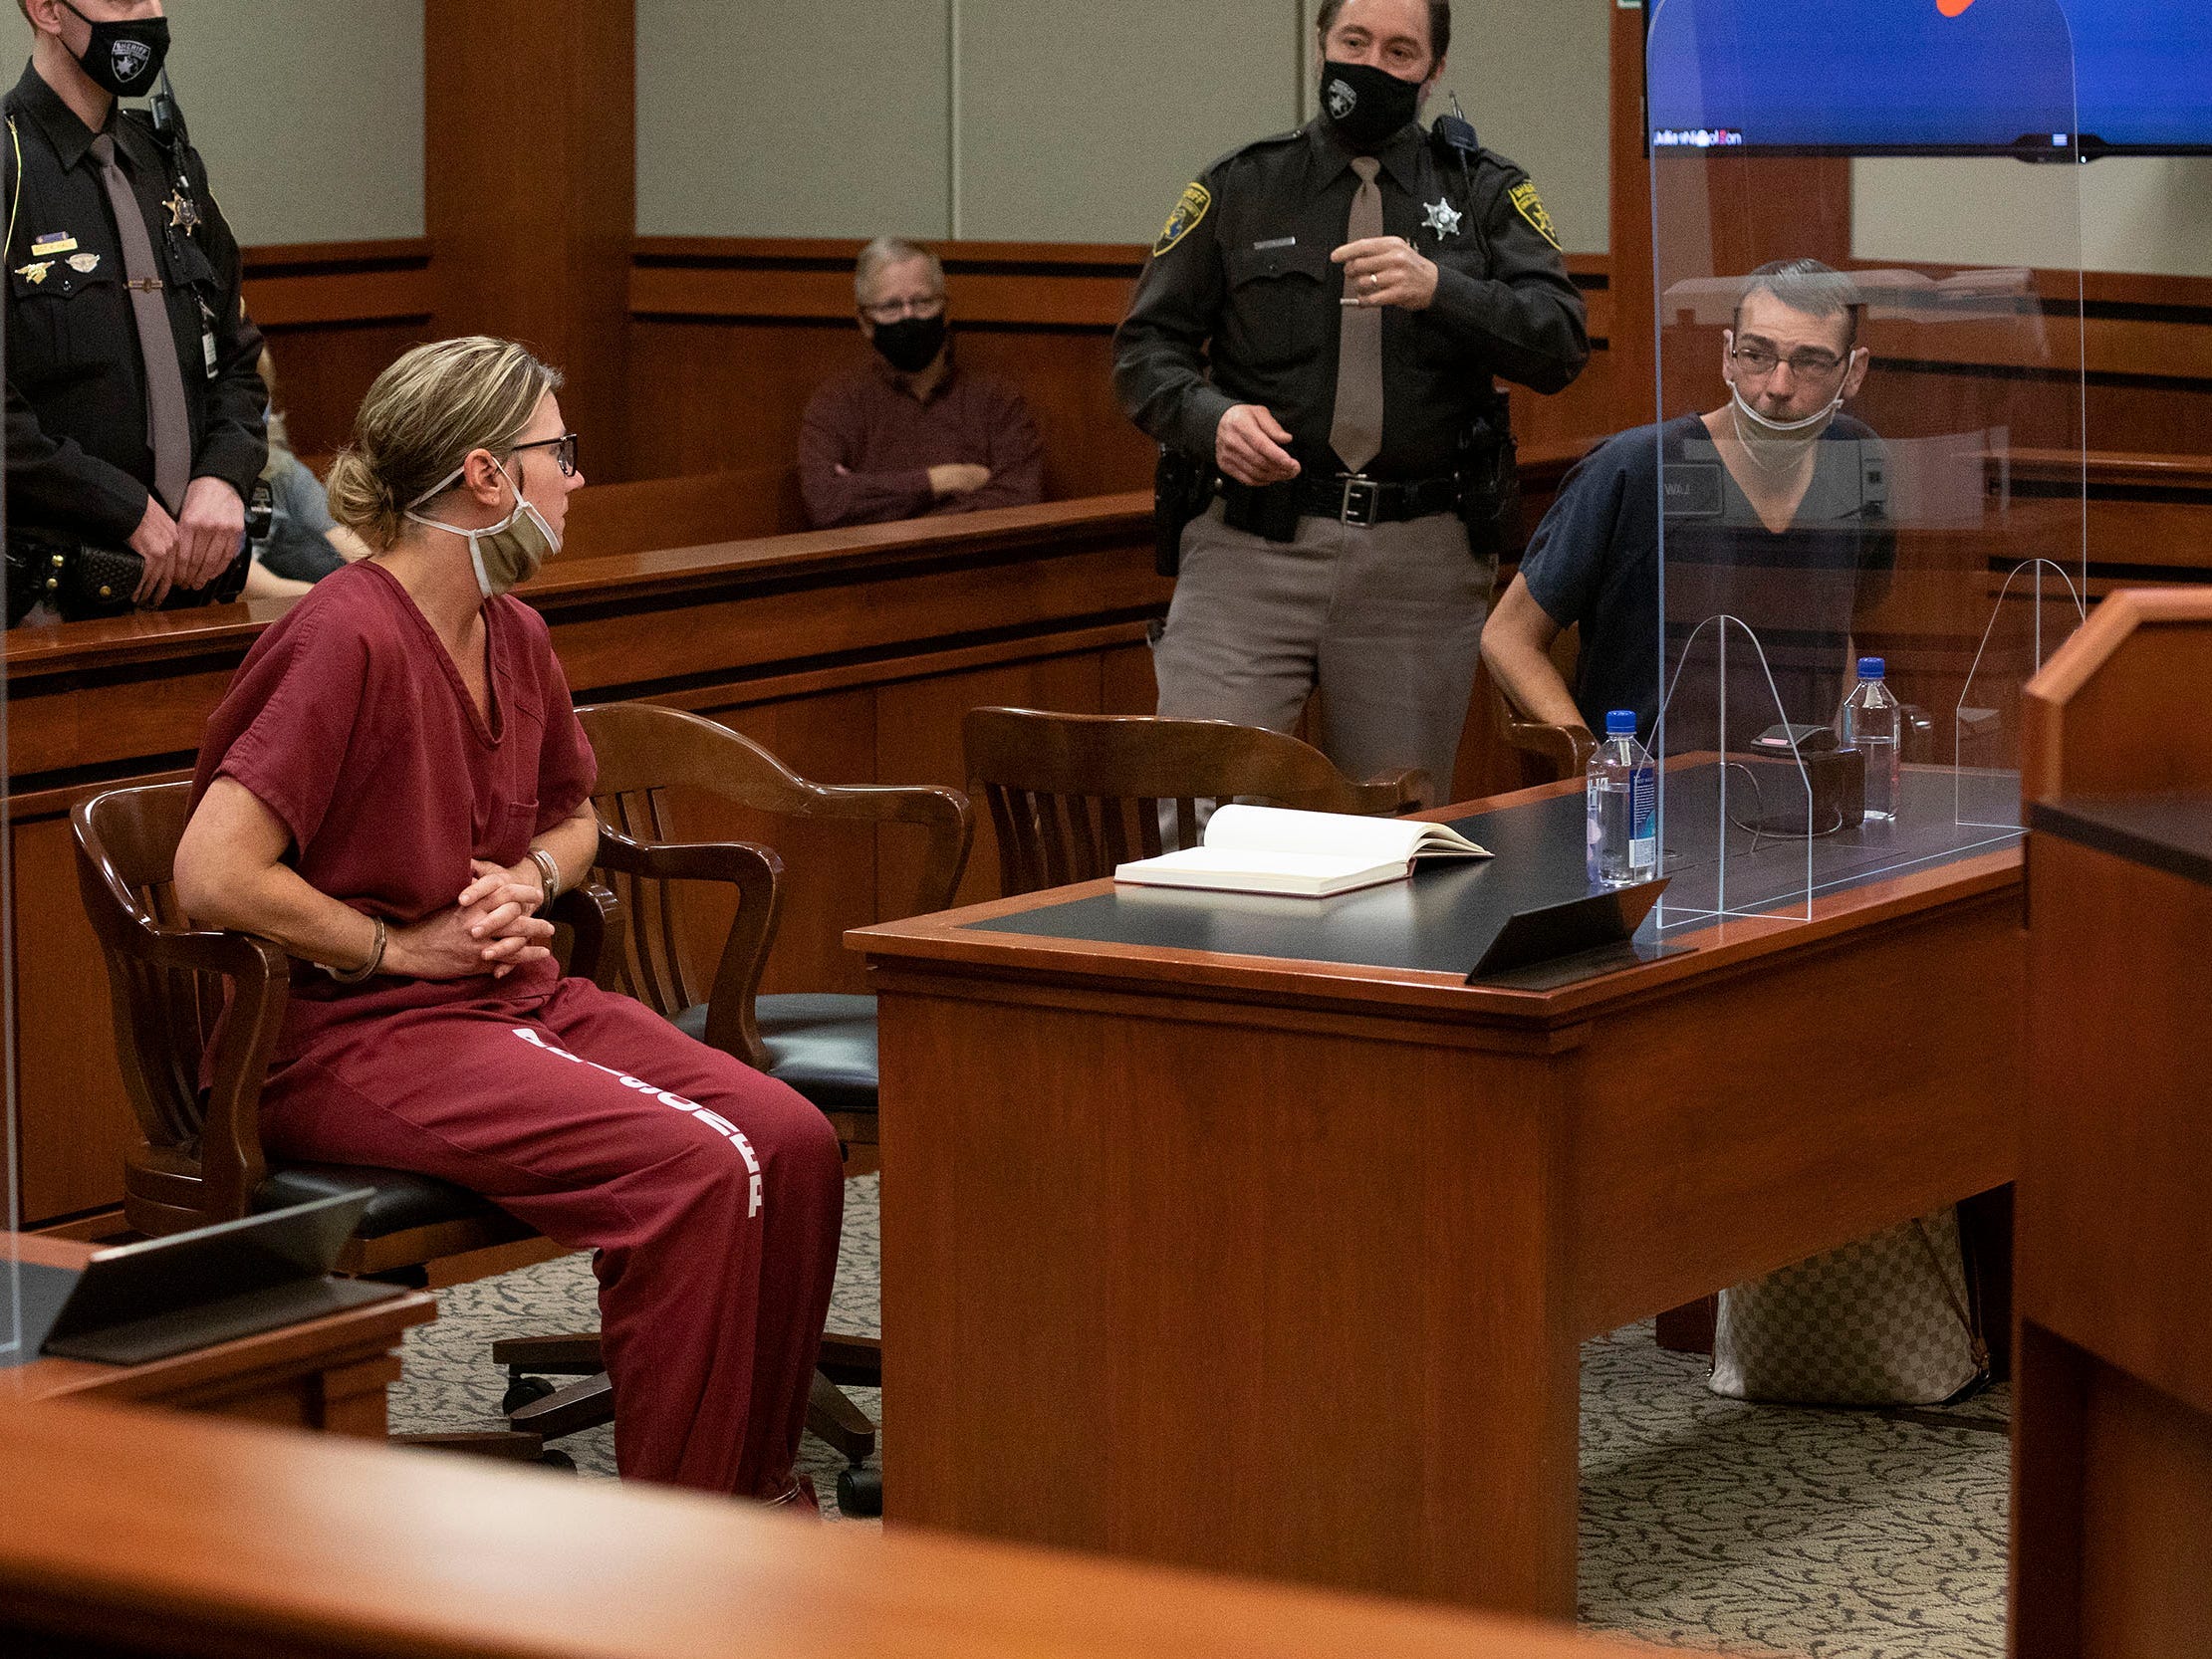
[13, 1190, 407, 1365]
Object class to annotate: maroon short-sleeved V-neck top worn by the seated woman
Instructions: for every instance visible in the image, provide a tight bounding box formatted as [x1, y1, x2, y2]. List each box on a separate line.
[192, 560, 598, 1062]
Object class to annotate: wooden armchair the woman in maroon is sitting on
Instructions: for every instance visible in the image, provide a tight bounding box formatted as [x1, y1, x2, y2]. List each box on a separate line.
[71, 783, 621, 1460]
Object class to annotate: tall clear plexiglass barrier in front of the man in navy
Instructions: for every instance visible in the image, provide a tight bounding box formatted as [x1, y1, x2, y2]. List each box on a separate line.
[1654, 0, 2086, 929]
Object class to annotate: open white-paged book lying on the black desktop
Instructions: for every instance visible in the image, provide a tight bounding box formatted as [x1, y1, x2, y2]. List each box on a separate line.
[1112, 806, 1491, 898]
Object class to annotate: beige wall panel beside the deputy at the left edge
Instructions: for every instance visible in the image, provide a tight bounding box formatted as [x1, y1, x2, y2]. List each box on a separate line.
[163, 0, 422, 246]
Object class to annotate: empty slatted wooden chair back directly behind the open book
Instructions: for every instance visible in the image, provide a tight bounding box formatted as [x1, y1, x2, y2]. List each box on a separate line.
[962, 708, 1427, 898]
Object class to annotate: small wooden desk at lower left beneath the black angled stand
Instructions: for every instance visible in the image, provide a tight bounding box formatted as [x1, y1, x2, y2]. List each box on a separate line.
[0, 1235, 438, 1433]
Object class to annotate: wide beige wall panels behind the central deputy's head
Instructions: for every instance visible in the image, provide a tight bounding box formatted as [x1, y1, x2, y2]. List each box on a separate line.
[637, 0, 1612, 252]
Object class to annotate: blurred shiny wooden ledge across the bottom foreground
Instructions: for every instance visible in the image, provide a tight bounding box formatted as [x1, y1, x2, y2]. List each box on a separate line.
[0, 1407, 1743, 1659]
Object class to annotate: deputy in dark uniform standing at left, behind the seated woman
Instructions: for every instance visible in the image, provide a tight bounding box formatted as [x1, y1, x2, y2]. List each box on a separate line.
[0, 0, 268, 623]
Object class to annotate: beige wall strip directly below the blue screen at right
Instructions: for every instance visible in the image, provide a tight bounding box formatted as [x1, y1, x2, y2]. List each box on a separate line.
[1851, 157, 2212, 277]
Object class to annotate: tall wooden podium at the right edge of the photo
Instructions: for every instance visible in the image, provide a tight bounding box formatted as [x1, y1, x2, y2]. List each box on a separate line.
[2011, 591, 2212, 1659]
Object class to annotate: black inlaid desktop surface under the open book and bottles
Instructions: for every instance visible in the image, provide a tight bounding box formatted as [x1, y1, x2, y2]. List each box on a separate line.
[964, 763, 2022, 973]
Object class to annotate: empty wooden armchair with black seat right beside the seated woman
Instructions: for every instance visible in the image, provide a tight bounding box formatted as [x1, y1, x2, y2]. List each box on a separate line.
[578, 703, 973, 1516]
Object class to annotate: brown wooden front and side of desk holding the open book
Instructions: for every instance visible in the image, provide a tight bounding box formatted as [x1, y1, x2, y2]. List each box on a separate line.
[852, 783, 2022, 1617]
